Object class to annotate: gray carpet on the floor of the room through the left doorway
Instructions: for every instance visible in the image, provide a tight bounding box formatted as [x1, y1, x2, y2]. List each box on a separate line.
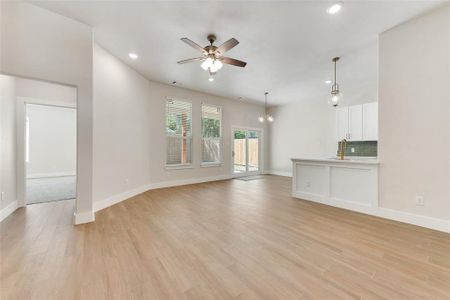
[26, 176, 76, 204]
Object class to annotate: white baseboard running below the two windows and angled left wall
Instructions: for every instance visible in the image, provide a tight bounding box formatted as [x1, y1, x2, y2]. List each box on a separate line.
[94, 174, 232, 212]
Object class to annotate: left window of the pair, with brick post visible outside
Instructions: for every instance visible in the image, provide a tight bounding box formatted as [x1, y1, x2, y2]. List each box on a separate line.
[166, 99, 192, 167]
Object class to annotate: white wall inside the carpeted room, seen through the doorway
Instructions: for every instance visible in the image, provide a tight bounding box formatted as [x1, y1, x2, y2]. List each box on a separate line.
[26, 104, 77, 178]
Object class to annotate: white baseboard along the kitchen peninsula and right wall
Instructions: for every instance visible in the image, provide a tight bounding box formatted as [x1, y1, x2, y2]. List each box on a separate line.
[292, 192, 450, 233]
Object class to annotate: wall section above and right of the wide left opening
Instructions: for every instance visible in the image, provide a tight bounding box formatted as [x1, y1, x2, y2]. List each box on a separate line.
[0, 1, 93, 222]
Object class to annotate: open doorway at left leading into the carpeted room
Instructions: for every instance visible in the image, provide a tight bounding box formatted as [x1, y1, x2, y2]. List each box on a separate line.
[24, 103, 77, 204]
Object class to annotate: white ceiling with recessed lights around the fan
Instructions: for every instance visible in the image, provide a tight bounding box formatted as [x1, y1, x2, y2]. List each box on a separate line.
[33, 0, 440, 105]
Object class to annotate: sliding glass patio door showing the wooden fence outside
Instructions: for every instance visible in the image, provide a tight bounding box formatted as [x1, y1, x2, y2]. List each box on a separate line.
[232, 128, 261, 177]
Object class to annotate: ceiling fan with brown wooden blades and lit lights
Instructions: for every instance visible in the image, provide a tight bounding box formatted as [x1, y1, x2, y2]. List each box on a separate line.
[178, 34, 247, 76]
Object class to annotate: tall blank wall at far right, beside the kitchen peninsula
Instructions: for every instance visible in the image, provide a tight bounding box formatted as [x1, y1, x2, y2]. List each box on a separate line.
[379, 6, 450, 220]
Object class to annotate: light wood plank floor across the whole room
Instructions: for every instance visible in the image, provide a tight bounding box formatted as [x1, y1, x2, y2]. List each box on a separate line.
[0, 176, 450, 300]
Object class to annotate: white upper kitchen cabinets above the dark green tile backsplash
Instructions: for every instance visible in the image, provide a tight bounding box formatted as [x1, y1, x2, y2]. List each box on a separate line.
[336, 102, 378, 141]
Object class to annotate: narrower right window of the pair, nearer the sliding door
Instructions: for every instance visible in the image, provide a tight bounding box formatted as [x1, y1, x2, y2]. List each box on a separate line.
[202, 104, 222, 165]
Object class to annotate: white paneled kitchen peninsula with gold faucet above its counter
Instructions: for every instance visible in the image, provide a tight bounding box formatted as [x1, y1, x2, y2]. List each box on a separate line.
[291, 157, 378, 214]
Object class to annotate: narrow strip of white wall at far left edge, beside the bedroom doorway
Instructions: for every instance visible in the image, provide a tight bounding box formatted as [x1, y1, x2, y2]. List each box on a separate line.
[0, 75, 17, 214]
